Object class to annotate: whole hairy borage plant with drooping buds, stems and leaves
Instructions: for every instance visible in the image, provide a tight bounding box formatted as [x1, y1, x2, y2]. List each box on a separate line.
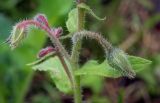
[7, 0, 151, 103]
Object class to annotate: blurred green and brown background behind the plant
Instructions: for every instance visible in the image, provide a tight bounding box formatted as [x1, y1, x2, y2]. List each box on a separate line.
[0, 0, 160, 103]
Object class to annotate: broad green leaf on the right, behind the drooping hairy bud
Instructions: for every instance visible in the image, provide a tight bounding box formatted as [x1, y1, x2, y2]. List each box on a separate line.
[75, 56, 151, 78]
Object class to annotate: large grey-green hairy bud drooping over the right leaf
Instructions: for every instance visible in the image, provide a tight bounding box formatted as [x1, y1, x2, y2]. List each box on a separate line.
[107, 48, 136, 78]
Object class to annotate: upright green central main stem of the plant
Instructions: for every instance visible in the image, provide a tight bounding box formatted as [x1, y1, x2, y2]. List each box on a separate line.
[71, 0, 85, 103]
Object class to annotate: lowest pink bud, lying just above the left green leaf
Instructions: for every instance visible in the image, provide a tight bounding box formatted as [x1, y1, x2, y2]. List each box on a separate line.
[38, 46, 56, 58]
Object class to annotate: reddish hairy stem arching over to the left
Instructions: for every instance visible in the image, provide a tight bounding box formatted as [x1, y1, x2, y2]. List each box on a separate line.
[17, 20, 75, 86]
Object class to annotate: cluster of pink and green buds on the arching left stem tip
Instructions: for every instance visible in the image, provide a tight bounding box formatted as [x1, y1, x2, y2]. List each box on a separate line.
[7, 14, 63, 49]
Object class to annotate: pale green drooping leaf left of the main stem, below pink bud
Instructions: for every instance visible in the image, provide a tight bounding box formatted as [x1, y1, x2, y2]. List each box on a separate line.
[32, 56, 71, 93]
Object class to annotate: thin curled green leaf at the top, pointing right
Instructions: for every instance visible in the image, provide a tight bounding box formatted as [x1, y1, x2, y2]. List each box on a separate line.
[78, 3, 106, 20]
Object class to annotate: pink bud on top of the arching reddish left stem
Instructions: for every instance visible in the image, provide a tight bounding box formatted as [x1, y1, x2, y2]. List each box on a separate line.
[34, 14, 50, 28]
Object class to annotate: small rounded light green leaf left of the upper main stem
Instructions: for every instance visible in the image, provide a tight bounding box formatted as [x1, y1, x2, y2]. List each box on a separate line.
[66, 8, 78, 33]
